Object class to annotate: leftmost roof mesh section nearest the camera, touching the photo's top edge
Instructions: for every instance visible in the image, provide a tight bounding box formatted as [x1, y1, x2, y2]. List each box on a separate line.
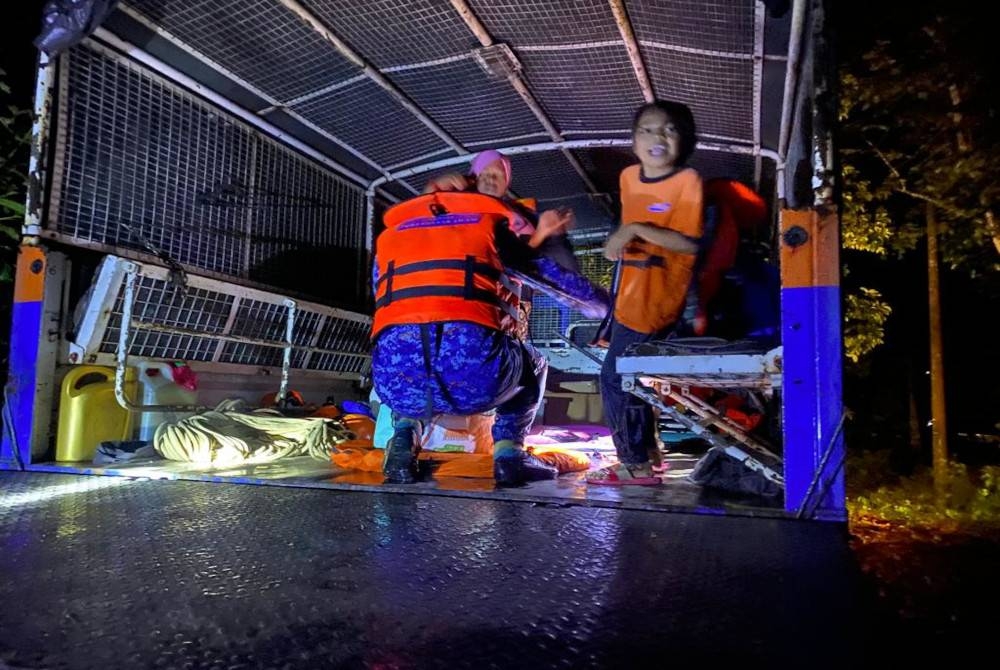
[126, 0, 358, 101]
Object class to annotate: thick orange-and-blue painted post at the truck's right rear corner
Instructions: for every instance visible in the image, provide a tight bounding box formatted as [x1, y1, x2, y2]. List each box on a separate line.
[780, 209, 846, 519]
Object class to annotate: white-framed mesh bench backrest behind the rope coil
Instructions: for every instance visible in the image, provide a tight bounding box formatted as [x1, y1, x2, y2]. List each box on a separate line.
[81, 256, 371, 378]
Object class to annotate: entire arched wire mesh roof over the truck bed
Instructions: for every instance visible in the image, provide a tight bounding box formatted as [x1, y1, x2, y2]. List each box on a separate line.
[109, 0, 768, 210]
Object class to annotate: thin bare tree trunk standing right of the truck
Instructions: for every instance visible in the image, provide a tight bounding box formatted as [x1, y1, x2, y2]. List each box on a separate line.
[927, 203, 949, 507]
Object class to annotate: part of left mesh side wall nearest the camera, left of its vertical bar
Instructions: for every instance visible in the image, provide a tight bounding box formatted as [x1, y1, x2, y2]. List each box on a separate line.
[59, 47, 255, 275]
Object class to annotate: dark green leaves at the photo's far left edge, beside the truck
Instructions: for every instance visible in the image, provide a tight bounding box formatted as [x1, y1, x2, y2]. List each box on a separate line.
[0, 70, 31, 282]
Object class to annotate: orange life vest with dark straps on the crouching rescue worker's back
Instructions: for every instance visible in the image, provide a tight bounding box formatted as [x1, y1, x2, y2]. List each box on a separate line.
[372, 192, 518, 338]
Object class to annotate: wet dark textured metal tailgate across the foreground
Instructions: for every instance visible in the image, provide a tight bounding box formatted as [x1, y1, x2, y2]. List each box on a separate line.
[0, 473, 864, 669]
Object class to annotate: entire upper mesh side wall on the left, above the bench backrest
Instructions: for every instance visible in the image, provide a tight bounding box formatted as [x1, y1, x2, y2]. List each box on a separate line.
[54, 45, 364, 304]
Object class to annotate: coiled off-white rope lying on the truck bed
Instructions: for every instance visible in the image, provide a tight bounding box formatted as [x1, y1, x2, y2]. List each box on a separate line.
[153, 400, 354, 465]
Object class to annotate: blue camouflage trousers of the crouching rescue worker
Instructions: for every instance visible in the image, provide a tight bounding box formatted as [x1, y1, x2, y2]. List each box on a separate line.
[372, 321, 548, 444]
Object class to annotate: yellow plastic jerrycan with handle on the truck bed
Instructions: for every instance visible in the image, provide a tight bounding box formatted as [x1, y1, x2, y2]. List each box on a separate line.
[56, 365, 136, 461]
